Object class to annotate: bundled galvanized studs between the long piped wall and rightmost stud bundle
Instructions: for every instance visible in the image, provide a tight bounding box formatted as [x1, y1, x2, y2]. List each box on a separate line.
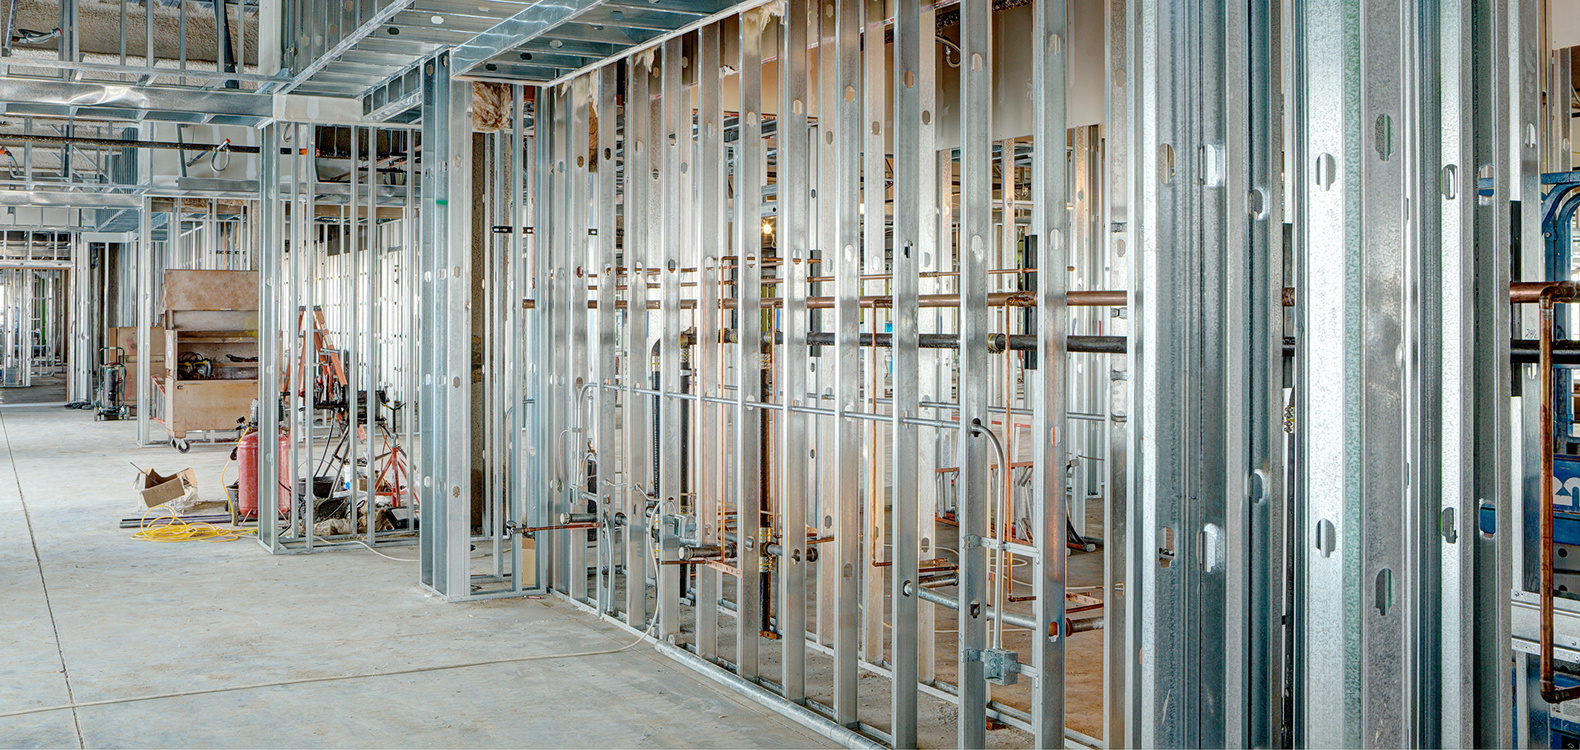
[1125, 2, 1288, 747]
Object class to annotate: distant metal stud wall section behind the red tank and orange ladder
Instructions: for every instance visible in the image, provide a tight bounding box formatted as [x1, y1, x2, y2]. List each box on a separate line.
[256, 122, 428, 554]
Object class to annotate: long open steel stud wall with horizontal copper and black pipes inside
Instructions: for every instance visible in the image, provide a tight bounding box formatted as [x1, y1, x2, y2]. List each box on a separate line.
[505, 0, 1125, 747]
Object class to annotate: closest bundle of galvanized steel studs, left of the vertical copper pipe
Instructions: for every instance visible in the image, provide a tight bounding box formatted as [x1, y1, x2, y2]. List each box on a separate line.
[1291, 2, 1510, 745]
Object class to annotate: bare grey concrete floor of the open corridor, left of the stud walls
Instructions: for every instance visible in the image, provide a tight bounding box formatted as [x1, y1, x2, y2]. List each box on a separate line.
[0, 407, 828, 747]
